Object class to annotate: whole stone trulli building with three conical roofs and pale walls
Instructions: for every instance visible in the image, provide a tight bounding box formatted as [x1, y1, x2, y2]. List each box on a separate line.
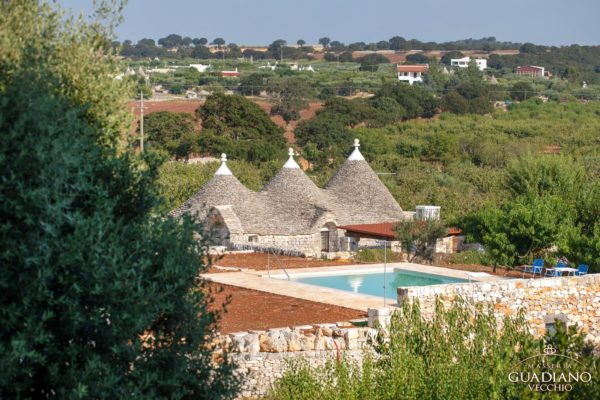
[172, 140, 405, 256]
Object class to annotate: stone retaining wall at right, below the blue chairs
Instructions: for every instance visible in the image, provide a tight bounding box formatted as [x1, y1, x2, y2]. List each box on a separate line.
[398, 274, 600, 346]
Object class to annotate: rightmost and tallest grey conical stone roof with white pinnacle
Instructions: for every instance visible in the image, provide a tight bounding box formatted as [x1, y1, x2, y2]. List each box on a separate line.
[325, 139, 402, 225]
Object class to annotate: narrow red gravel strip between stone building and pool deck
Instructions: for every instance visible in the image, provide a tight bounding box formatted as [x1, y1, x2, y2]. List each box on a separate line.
[210, 253, 352, 272]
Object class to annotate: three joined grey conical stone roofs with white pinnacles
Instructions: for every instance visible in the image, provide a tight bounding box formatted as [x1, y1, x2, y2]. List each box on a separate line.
[171, 140, 402, 239]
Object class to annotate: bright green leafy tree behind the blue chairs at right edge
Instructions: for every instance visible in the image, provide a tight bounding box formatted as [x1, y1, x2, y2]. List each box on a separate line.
[467, 156, 600, 269]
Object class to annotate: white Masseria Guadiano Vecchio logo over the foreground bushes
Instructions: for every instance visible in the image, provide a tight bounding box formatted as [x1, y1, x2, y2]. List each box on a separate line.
[508, 344, 592, 392]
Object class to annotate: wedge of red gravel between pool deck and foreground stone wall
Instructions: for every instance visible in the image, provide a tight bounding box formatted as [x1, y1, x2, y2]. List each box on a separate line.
[209, 283, 366, 333]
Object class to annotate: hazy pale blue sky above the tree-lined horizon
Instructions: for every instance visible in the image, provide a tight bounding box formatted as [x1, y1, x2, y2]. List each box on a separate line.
[58, 0, 600, 45]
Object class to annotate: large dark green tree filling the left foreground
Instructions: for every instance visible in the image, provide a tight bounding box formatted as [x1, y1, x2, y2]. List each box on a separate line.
[0, 0, 238, 399]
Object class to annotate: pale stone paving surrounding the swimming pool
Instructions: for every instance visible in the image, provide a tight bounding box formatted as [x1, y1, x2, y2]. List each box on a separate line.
[202, 263, 505, 311]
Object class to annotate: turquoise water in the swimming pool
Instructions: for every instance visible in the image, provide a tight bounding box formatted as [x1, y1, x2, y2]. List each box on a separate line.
[292, 270, 468, 299]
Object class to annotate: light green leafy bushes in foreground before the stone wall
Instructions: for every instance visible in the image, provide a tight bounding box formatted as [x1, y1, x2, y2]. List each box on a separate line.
[269, 299, 600, 400]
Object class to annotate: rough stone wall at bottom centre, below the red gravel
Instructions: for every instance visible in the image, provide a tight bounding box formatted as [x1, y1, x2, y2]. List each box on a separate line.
[221, 322, 376, 398]
